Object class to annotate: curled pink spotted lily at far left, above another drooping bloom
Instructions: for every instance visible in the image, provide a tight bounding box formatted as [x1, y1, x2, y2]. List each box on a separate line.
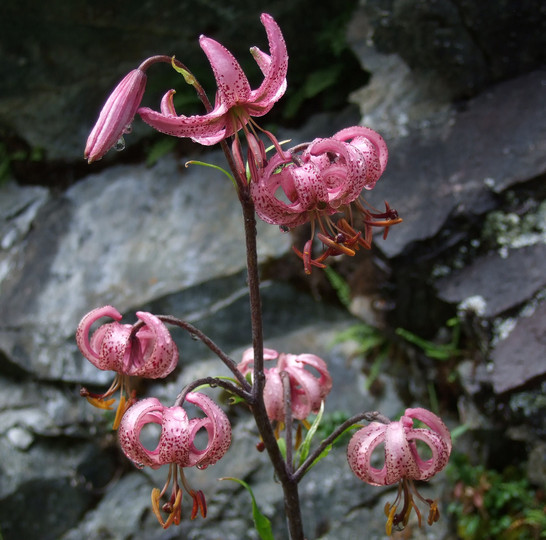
[76, 306, 178, 429]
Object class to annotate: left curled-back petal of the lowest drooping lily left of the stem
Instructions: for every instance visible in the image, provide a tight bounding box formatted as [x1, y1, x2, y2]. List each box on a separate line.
[118, 398, 164, 469]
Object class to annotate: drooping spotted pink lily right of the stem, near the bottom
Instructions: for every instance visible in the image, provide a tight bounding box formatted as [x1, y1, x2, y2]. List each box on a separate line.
[347, 408, 452, 535]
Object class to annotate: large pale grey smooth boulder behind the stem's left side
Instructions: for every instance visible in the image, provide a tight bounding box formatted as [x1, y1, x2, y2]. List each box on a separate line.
[0, 153, 289, 383]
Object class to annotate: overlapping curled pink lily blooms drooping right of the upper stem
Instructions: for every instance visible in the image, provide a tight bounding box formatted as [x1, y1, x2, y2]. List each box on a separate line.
[250, 126, 402, 273]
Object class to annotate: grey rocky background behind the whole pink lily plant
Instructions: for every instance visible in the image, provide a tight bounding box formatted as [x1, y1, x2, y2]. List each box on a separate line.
[0, 0, 546, 540]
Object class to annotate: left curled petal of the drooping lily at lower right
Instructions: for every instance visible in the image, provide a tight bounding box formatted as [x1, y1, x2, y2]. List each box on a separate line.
[347, 422, 387, 486]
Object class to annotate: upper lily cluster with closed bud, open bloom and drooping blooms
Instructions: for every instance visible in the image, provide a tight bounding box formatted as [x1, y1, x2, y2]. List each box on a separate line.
[84, 14, 402, 274]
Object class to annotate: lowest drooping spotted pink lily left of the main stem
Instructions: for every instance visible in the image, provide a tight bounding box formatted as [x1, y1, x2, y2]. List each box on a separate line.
[118, 392, 231, 529]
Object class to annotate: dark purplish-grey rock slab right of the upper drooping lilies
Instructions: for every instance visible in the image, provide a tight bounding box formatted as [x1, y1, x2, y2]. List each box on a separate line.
[369, 71, 546, 258]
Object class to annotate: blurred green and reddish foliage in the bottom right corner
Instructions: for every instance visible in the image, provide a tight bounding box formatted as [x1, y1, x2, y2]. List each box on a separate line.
[447, 453, 546, 540]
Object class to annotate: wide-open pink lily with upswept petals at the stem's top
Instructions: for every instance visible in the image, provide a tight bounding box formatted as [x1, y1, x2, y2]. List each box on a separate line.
[138, 13, 288, 146]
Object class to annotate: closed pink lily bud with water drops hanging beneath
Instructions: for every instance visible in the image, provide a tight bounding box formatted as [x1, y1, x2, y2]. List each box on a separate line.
[84, 68, 146, 163]
